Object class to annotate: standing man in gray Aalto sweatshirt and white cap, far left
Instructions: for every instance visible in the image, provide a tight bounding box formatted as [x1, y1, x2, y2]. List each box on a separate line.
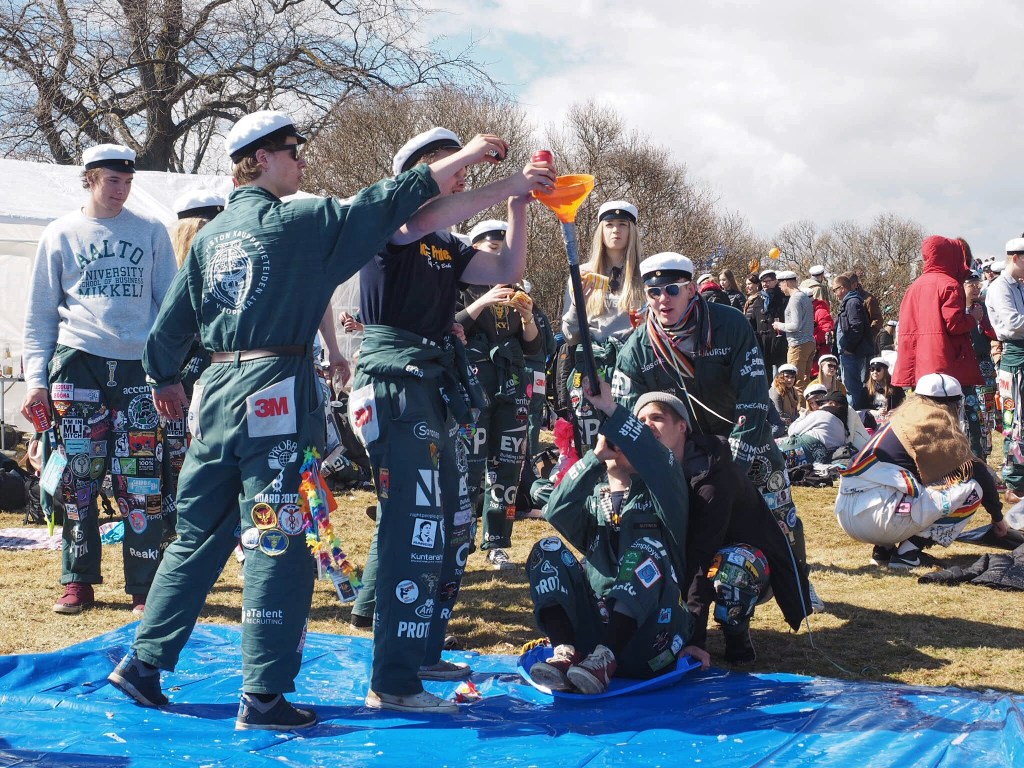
[22, 144, 175, 613]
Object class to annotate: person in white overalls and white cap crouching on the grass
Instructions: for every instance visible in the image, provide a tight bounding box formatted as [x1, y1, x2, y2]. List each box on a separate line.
[836, 374, 1007, 570]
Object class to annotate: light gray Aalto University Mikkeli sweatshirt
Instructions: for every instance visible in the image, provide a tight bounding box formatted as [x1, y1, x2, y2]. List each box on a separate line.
[24, 209, 177, 389]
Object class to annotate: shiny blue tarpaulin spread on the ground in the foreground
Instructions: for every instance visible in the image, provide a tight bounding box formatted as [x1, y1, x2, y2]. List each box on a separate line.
[0, 625, 1024, 768]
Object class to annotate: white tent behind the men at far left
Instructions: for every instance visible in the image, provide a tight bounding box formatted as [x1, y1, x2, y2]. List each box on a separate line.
[0, 159, 358, 442]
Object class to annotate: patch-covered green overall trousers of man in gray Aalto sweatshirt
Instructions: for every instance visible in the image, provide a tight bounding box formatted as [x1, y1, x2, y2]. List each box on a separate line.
[44, 344, 165, 595]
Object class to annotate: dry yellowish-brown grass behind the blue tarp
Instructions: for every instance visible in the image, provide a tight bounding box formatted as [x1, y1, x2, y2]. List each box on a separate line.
[0, 460, 1024, 693]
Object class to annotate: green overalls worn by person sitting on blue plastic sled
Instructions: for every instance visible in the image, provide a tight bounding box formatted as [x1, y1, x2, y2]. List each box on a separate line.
[527, 408, 693, 678]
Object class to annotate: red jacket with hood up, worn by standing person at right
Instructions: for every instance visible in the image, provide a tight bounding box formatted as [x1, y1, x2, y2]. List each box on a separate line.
[892, 236, 984, 387]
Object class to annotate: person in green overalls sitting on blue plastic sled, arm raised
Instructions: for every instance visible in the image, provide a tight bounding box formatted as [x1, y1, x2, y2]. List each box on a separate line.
[527, 381, 709, 694]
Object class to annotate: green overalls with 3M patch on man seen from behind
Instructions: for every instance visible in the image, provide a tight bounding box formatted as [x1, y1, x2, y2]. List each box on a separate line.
[133, 166, 437, 693]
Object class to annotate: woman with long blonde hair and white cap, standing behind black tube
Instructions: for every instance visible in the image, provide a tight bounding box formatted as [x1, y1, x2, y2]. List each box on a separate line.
[562, 200, 647, 447]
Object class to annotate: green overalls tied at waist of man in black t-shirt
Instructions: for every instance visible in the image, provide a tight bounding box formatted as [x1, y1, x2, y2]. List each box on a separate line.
[349, 326, 482, 695]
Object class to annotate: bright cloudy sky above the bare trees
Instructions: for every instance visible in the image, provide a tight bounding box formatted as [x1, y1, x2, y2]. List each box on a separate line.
[419, 0, 1024, 256]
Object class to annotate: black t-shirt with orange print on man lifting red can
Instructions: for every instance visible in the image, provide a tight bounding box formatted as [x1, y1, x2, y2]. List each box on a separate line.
[359, 231, 477, 342]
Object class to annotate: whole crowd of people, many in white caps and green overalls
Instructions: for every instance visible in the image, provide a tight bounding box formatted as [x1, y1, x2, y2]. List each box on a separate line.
[12, 112, 1024, 730]
